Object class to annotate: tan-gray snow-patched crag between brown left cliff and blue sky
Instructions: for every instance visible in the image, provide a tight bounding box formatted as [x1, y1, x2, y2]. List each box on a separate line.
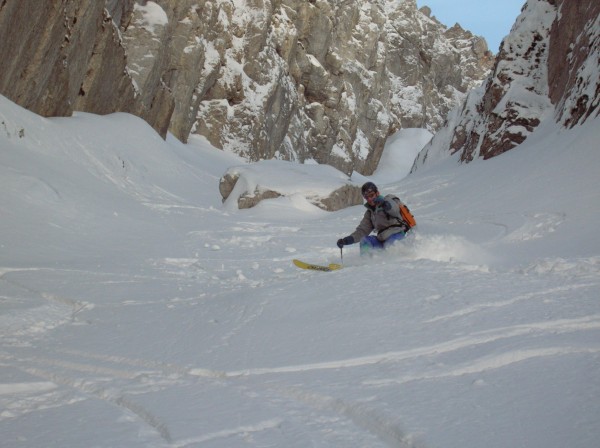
[154, 0, 492, 173]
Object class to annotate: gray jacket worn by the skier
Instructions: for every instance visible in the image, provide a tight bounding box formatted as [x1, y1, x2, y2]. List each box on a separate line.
[350, 194, 407, 243]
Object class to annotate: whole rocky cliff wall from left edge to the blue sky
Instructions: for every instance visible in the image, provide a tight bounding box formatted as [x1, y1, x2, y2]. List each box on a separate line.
[0, 0, 492, 174]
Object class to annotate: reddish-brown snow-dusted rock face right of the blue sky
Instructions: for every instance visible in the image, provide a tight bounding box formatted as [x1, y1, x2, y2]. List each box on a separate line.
[413, 0, 600, 170]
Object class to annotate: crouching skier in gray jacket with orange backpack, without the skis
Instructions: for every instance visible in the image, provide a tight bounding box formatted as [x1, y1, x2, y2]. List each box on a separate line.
[337, 182, 410, 255]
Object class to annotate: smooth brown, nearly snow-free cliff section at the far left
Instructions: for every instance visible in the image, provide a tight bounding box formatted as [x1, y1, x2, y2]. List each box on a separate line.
[0, 0, 173, 135]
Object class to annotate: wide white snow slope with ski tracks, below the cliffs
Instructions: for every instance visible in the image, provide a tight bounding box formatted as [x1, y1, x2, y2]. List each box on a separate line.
[0, 93, 600, 448]
